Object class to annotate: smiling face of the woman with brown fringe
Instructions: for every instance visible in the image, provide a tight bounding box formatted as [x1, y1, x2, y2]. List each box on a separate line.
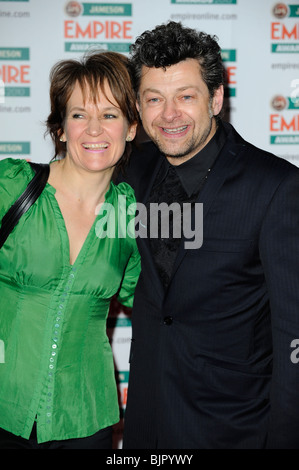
[61, 82, 136, 172]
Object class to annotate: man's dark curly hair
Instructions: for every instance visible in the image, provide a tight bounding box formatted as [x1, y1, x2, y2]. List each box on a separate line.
[130, 21, 224, 97]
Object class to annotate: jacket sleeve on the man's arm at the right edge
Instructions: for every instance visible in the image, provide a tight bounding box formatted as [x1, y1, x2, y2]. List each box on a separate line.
[260, 169, 299, 449]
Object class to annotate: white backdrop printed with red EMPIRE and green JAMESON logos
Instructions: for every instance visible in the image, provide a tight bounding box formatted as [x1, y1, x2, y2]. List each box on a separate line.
[0, 0, 299, 445]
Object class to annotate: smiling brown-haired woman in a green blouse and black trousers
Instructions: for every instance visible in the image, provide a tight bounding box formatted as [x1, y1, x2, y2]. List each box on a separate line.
[0, 52, 140, 449]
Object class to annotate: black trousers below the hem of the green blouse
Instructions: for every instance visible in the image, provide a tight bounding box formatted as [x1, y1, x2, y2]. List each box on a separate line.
[0, 424, 112, 449]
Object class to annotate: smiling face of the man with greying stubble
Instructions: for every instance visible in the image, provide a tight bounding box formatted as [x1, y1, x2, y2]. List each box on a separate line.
[137, 59, 223, 165]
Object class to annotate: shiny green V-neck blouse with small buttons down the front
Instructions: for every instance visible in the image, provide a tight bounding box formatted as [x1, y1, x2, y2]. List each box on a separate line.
[0, 159, 140, 443]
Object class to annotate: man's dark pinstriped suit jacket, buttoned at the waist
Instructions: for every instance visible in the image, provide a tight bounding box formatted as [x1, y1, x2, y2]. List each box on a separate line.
[118, 124, 299, 449]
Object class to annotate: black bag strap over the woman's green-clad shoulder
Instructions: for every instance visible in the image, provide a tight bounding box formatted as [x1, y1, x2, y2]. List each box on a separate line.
[0, 162, 50, 248]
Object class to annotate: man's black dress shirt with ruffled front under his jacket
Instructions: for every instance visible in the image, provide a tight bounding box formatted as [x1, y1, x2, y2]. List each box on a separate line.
[146, 122, 226, 288]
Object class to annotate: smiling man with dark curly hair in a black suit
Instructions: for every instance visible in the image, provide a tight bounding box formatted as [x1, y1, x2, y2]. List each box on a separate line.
[120, 22, 299, 449]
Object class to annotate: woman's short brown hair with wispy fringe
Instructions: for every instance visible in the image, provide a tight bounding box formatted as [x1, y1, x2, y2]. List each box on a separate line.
[46, 50, 138, 164]
